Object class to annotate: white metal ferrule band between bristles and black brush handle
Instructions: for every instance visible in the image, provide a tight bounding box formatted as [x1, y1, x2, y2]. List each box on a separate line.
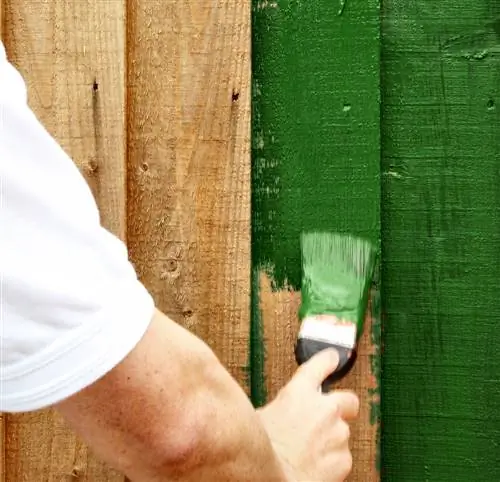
[298, 315, 357, 350]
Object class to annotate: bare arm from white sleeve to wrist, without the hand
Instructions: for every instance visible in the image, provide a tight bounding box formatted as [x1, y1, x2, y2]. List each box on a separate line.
[57, 312, 284, 482]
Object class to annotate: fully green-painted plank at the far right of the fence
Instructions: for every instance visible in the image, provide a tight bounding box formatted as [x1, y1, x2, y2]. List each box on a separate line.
[382, 0, 500, 482]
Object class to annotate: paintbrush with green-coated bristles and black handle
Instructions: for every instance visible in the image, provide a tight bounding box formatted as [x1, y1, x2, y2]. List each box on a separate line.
[295, 232, 377, 392]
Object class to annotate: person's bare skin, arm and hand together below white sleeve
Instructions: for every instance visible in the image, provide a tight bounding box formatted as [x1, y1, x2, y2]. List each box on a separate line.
[55, 311, 359, 482]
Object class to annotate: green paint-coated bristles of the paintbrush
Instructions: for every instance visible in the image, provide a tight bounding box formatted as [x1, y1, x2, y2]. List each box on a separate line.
[299, 232, 377, 338]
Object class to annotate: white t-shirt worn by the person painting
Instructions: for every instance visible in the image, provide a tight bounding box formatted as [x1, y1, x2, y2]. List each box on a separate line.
[0, 42, 154, 412]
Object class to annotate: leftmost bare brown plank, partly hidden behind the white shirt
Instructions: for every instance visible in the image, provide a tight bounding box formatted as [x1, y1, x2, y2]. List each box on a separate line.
[4, 0, 126, 482]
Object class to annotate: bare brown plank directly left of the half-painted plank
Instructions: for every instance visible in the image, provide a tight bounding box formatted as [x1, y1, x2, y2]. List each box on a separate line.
[128, 0, 250, 385]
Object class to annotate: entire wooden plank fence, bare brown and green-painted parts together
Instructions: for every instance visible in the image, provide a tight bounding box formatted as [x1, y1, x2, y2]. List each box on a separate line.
[0, 0, 500, 482]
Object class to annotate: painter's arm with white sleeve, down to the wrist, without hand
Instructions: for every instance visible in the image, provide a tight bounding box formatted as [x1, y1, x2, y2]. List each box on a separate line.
[0, 43, 288, 482]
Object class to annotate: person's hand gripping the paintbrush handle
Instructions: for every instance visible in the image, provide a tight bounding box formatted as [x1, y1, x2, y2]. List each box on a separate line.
[257, 350, 359, 482]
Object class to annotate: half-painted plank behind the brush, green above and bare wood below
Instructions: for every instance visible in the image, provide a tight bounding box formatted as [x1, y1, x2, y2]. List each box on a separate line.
[251, 0, 380, 482]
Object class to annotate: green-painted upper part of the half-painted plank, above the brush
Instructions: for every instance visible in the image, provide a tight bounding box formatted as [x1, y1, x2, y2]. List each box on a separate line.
[252, 0, 379, 286]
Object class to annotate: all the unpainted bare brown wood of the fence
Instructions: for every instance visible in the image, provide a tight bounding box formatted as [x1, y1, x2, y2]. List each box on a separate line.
[2, 0, 376, 482]
